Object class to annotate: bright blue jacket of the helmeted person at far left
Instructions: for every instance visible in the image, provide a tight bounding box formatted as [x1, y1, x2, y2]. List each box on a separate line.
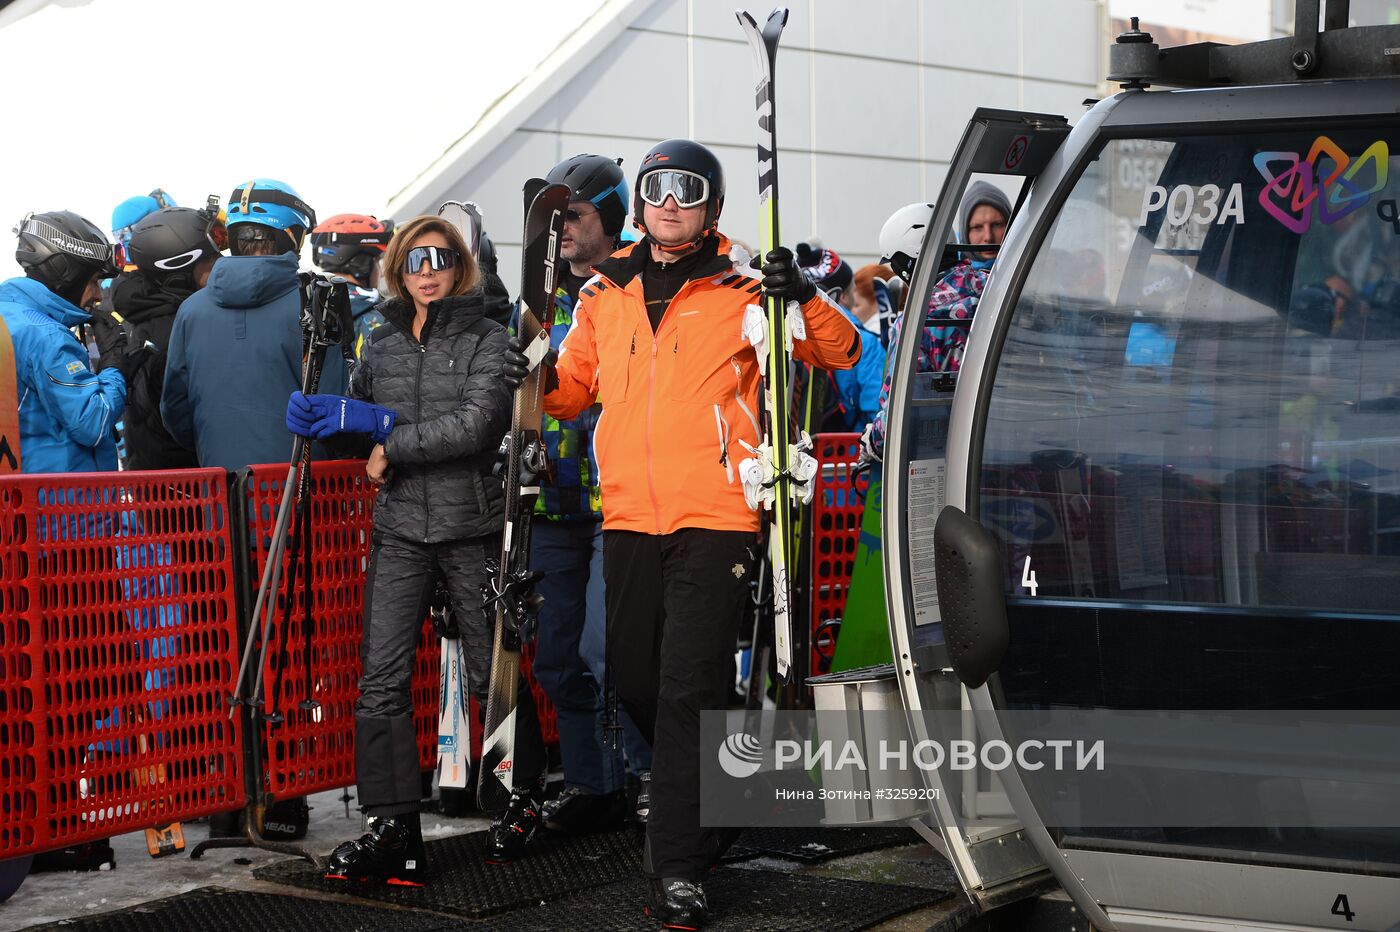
[0, 272, 126, 473]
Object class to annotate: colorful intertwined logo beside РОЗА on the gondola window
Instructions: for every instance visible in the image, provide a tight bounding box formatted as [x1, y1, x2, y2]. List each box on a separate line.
[1254, 136, 1390, 234]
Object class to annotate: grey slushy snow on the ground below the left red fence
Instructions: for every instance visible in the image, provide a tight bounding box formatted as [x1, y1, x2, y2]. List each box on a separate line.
[0, 789, 490, 932]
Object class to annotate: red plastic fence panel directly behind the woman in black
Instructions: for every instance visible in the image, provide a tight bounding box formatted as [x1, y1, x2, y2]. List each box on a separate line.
[245, 460, 559, 799]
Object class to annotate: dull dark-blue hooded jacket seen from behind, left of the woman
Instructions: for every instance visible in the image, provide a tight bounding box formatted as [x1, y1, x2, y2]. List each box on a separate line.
[161, 252, 347, 470]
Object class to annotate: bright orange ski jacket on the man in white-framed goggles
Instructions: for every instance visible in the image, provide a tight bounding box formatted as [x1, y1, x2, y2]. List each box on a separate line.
[545, 235, 861, 535]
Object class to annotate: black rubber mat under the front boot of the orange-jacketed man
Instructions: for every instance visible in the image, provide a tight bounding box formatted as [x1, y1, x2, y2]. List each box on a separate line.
[491, 868, 952, 932]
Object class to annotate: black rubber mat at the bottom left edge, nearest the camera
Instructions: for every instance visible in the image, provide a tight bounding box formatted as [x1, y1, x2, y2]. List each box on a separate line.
[21, 887, 463, 932]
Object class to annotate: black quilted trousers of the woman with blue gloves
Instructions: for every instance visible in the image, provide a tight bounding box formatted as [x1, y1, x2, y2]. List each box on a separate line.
[354, 535, 547, 816]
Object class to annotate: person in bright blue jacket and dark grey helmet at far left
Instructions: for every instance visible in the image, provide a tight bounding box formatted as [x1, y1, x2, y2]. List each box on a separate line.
[0, 210, 126, 473]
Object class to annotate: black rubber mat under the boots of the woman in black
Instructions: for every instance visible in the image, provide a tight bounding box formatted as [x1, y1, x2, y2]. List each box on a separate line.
[256, 831, 641, 912]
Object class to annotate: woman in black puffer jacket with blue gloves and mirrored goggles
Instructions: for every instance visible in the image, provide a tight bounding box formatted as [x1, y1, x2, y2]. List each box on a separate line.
[287, 217, 546, 883]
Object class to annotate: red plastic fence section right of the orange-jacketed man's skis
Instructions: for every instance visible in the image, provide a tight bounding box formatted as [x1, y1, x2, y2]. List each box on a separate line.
[811, 434, 869, 673]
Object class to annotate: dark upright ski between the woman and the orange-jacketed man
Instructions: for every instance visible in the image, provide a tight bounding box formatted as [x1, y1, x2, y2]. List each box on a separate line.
[476, 178, 568, 812]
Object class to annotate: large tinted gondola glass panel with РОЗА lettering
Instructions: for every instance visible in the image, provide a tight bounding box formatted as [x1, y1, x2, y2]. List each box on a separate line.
[980, 129, 1400, 865]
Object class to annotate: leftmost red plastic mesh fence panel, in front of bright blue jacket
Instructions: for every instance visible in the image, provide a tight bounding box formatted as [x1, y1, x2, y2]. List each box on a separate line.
[0, 469, 245, 858]
